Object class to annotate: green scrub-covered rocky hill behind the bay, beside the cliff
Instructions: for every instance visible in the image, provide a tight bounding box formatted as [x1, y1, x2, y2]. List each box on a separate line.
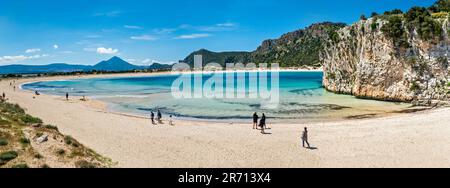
[184, 22, 345, 67]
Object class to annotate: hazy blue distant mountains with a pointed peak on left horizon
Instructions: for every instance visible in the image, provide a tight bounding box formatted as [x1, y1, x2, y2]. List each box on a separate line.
[0, 57, 172, 74]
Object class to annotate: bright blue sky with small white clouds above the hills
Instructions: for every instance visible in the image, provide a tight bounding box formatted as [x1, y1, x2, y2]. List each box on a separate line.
[0, 0, 434, 65]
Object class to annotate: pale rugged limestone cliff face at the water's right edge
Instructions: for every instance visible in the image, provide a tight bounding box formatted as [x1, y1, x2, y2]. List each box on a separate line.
[321, 17, 450, 101]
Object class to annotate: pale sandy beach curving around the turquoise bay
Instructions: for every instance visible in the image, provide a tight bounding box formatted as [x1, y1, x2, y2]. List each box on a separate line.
[0, 74, 450, 168]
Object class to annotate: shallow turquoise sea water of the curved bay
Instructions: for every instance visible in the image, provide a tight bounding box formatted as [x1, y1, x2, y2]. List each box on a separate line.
[22, 72, 408, 122]
